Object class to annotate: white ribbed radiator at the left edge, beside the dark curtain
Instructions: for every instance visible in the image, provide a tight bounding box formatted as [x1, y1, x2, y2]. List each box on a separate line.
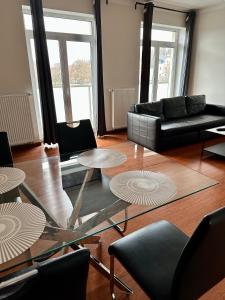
[0, 94, 35, 146]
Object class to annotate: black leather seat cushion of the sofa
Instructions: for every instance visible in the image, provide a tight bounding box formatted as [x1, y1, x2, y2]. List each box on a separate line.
[161, 114, 225, 136]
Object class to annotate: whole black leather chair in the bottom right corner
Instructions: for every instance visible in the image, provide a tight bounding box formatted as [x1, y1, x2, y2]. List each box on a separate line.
[109, 208, 225, 300]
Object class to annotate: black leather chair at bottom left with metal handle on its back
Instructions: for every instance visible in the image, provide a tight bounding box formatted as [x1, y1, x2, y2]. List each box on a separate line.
[0, 249, 90, 300]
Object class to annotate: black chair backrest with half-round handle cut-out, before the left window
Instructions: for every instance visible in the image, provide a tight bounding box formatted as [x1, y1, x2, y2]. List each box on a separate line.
[57, 119, 97, 160]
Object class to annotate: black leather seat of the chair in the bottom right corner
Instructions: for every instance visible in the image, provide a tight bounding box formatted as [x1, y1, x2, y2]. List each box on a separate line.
[109, 221, 189, 300]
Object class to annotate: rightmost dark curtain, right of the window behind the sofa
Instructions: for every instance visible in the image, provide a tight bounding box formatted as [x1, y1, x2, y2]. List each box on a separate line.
[180, 10, 196, 96]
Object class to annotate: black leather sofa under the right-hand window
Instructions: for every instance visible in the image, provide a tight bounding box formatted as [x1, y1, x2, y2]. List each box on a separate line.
[128, 95, 225, 151]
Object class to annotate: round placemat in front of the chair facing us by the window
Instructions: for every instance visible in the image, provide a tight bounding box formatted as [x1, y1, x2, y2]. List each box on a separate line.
[78, 148, 127, 168]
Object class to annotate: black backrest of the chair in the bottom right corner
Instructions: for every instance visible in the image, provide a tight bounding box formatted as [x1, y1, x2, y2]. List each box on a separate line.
[171, 208, 225, 300]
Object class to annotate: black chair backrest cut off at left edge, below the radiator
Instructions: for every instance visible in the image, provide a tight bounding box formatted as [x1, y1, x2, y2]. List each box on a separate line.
[0, 132, 13, 167]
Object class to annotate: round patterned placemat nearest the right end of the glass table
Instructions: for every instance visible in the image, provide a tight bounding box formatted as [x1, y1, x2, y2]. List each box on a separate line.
[109, 171, 176, 207]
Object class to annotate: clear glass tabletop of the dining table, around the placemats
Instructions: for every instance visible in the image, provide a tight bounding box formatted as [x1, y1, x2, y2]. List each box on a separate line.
[0, 142, 218, 272]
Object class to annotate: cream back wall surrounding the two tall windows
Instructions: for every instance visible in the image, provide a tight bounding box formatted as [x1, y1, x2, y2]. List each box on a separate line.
[0, 0, 184, 130]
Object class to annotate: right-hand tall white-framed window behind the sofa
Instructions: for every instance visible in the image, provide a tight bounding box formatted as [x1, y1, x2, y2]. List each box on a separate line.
[140, 25, 179, 102]
